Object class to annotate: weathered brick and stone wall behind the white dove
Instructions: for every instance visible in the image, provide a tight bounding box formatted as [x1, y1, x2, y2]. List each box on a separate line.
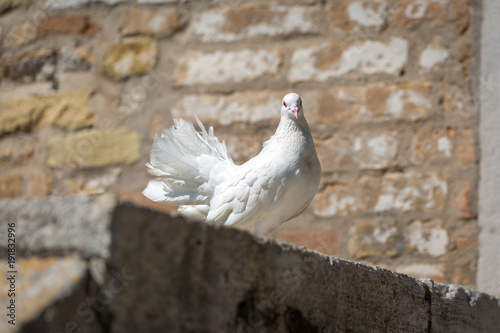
[0, 0, 481, 287]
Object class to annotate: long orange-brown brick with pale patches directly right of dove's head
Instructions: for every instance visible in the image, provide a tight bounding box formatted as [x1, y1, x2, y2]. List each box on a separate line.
[302, 82, 433, 126]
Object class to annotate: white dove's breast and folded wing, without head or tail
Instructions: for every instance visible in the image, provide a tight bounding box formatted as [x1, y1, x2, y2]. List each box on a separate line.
[207, 118, 321, 234]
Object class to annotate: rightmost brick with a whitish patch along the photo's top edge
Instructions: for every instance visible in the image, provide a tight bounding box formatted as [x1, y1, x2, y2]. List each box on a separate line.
[392, 0, 448, 28]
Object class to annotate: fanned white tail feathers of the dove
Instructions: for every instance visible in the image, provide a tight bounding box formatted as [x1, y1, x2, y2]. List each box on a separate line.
[142, 117, 234, 219]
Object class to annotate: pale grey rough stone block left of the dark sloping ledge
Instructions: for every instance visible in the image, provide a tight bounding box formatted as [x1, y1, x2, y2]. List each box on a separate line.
[0, 195, 115, 258]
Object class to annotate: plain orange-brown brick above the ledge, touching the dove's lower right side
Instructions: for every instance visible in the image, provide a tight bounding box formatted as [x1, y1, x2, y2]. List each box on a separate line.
[278, 229, 340, 255]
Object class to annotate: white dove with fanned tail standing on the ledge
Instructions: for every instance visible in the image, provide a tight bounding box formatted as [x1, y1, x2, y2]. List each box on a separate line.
[142, 93, 321, 234]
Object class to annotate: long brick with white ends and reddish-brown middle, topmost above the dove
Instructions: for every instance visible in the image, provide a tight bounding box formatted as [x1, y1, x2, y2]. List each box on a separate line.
[192, 3, 320, 42]
